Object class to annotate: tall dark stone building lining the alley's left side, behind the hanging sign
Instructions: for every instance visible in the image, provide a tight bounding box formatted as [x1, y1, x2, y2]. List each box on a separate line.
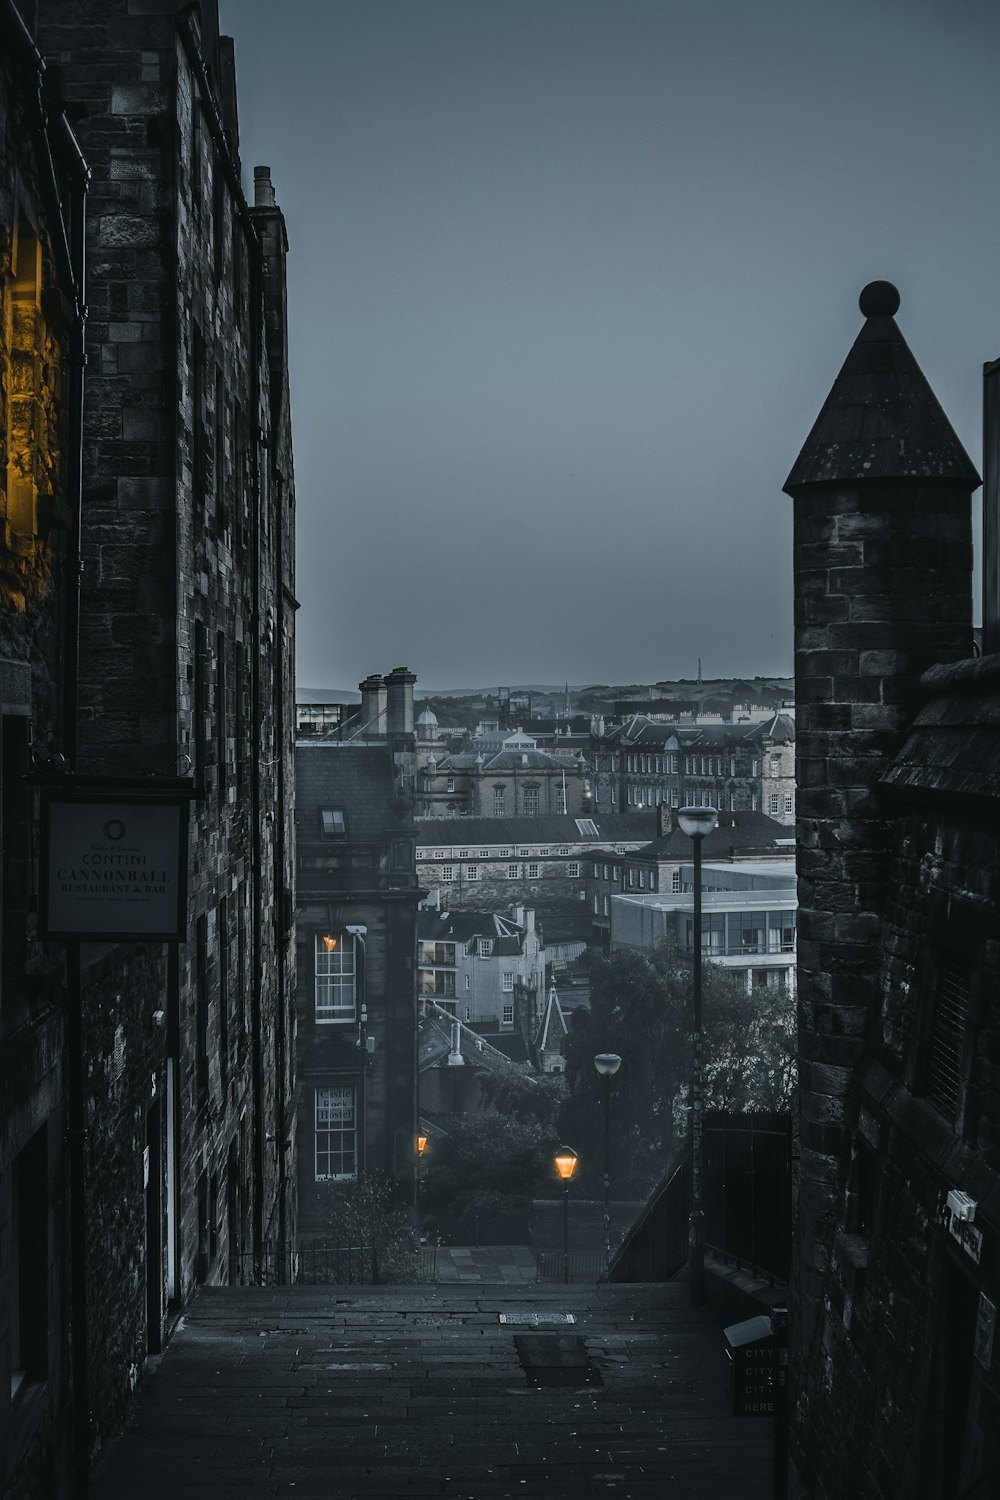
[0, 0, 294, 1500]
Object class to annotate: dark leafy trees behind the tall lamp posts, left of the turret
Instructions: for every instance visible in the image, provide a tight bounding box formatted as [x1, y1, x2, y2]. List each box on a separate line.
[561, 944, 795, 1196]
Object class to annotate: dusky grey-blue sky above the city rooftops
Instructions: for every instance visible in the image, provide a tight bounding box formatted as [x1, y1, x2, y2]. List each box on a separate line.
[222, 0, 1000, 689]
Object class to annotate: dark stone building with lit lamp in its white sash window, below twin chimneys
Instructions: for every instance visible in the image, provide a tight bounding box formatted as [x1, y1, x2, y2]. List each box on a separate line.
[295, 669, 420, 1236]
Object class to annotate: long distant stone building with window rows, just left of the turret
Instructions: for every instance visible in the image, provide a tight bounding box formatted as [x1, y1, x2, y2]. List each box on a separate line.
[591, 714, 795, 828]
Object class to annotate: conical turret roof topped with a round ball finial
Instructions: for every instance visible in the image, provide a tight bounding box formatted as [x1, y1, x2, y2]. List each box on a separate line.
[784, 282, 981, 495]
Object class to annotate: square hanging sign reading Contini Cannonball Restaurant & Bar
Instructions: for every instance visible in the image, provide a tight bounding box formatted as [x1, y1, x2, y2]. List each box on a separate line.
[39, 789, 187, 942]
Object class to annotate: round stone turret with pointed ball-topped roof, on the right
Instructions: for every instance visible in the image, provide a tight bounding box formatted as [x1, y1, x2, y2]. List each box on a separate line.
[784, 282, 979, 1358]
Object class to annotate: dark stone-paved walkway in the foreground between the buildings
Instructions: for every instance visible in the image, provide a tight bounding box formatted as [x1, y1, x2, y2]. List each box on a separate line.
[91, 1283, 771, 1500]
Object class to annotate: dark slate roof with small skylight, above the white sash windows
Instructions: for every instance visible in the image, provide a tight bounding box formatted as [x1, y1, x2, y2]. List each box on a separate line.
[295, 740, 409, 843]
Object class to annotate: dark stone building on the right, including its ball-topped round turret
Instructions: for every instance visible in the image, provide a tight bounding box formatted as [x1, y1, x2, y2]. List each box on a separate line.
[786, 282, 1000, 1500]
